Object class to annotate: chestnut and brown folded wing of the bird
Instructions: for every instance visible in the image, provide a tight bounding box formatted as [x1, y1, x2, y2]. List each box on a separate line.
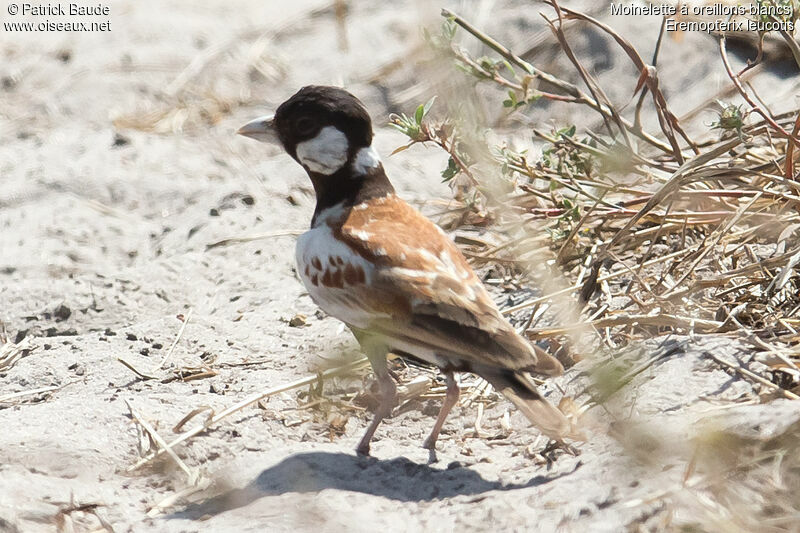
[331, 195, 563, 375]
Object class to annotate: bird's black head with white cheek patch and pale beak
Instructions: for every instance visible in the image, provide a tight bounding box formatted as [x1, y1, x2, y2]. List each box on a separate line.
[237, 85, 381, 178]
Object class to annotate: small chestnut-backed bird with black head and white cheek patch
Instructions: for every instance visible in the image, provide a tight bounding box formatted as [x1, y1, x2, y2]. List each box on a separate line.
[238, 86, 572, 455]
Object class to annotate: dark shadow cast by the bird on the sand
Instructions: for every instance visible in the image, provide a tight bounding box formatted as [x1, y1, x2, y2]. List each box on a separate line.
[169, 452, 580, 520]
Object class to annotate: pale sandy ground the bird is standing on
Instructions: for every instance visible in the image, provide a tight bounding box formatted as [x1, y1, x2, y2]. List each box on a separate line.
[0, 0, 792, 532]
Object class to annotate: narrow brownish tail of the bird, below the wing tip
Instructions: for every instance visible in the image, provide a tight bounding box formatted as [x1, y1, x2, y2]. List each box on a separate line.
[480, 370, 580, 442]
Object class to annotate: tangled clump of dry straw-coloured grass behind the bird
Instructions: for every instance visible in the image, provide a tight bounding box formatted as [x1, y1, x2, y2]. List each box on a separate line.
[386, 2, 800, 385]
